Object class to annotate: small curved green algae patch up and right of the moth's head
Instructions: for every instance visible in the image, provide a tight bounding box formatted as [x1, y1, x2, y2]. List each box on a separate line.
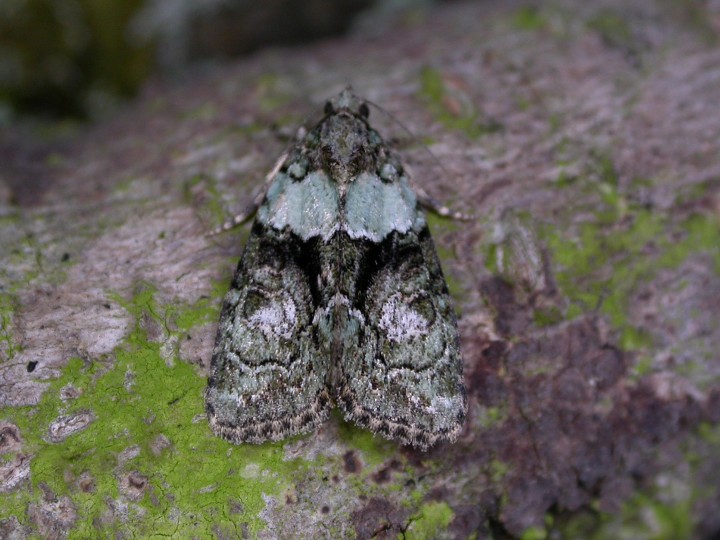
[420, 67, 502, 139]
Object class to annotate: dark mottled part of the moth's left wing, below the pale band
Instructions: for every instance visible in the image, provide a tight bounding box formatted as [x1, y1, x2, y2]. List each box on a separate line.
[205, 219, 329, 443]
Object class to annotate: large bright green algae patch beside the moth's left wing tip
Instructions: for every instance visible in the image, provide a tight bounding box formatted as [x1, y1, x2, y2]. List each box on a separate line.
[0, 287, 316, 538]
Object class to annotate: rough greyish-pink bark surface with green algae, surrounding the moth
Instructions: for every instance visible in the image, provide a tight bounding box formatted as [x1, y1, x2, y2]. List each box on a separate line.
[0, 0, 720, 539]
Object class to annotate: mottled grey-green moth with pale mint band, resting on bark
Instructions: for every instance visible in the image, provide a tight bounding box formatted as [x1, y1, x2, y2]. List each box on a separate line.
[205, 87, 466, 450]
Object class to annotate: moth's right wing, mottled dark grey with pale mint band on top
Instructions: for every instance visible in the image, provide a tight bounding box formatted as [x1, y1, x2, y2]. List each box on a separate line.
[337, 176, 466, 449]
